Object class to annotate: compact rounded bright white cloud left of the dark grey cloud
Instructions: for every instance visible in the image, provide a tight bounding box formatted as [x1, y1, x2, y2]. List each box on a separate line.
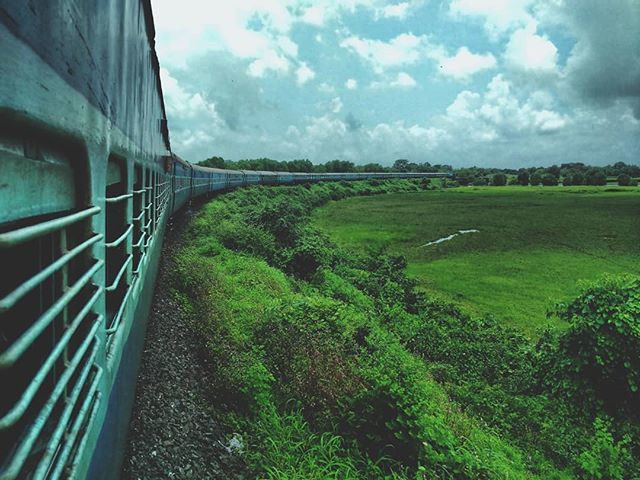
[504, 22, 558, 73]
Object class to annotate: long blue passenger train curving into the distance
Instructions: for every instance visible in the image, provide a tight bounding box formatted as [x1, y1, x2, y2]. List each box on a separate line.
[0, 0, 446, 480]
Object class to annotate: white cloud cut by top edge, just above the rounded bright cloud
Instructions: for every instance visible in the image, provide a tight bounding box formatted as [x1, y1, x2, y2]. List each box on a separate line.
[449, 0, 534, 39]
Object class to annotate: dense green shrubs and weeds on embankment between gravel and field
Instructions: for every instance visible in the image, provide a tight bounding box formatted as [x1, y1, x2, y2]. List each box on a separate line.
[174, 181, 640, 479]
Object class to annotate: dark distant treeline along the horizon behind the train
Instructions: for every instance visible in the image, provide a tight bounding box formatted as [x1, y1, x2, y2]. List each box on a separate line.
[200, 157, 640, 186]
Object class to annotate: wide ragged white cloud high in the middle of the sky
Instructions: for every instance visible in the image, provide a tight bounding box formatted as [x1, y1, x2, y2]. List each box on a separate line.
[340, 33, 427, 73]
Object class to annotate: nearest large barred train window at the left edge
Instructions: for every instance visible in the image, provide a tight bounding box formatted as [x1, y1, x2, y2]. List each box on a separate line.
[0, 128, 102, 478]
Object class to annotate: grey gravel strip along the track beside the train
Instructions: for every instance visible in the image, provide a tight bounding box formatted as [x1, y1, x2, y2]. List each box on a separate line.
[122, 204, 247, 479]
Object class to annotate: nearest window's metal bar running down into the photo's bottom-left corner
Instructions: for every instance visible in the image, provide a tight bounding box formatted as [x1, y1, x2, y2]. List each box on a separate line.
[3, 316, 102, 480]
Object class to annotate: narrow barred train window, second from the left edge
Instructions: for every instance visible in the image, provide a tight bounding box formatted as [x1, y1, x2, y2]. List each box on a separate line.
[104, 155, 133, 344]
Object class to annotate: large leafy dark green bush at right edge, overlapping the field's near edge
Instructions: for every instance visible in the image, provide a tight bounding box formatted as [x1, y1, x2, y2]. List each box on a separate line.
[542, 276, 640, 416]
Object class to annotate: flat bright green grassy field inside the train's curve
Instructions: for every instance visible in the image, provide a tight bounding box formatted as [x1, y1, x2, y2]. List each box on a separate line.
[314, 187, 640, 336]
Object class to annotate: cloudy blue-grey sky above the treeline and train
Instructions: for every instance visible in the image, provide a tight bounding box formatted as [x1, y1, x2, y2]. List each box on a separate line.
[152, 0, 640, 168]
